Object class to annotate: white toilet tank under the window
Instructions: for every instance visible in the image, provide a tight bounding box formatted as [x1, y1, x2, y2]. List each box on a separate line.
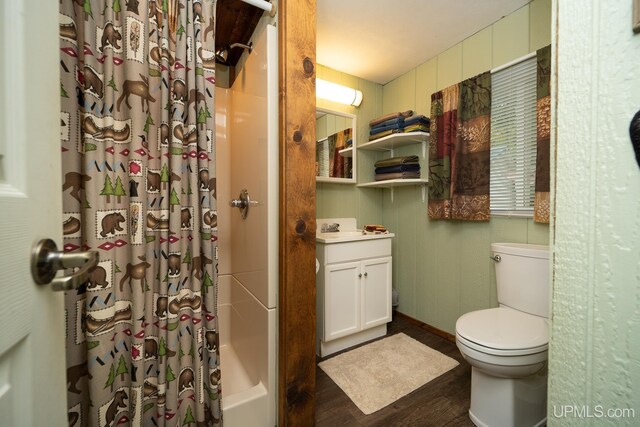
[491, 243, 549, 318]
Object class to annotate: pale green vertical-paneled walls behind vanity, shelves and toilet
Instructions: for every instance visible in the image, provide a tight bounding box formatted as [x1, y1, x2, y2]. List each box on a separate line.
[317, 0, 551, 333]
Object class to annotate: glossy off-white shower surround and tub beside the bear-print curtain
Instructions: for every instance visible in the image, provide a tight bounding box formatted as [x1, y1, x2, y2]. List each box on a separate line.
[216, 25, 278, 427]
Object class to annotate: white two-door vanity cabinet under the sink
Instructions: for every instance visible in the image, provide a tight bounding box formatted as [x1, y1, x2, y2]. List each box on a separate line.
[316, 238, 392, 357]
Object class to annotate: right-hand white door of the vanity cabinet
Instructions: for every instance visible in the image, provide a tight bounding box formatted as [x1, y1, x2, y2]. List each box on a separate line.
[362, 257, 391, 329]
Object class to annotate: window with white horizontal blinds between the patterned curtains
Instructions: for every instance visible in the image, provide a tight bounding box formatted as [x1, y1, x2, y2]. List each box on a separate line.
[490, 54, 537, 216]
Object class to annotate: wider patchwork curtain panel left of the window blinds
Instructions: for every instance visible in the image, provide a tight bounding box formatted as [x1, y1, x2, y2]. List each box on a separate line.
[427, 72, 491, 221]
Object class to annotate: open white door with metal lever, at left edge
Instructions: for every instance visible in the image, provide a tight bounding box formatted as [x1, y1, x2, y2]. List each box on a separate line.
[0, 0, 67, 426]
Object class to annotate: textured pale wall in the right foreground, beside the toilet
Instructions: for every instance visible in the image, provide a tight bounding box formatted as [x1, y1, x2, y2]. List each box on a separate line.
[548, 0, 640, 426]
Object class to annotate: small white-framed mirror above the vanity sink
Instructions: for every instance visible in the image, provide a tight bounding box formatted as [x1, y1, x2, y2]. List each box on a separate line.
[316, 108, 356, 184]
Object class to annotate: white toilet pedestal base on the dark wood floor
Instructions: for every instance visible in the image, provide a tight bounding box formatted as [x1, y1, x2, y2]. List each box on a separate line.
[469, 367, 547, 427]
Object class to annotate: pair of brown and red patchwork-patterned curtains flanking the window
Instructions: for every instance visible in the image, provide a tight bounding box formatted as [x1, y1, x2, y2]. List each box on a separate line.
[428, 46, 551, 223]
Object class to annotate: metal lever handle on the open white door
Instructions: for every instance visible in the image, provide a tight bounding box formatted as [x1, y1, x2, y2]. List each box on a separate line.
[31, 239, 99, 291]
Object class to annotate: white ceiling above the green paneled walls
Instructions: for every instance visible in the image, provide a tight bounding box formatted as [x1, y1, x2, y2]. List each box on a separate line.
[316, 0, 531, 84]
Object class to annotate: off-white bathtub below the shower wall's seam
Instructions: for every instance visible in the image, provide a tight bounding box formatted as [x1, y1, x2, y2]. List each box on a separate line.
[218, 275, 276, 427]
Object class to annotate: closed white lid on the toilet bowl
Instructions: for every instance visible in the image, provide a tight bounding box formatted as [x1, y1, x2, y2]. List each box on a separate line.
[456, 307, 549, 351]
